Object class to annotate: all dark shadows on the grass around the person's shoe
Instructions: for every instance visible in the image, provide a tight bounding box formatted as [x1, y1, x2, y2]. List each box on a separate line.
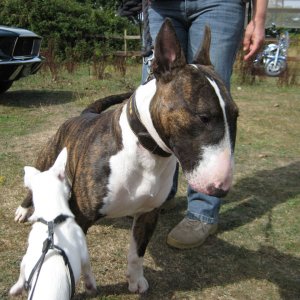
[95, 162, 300, 300]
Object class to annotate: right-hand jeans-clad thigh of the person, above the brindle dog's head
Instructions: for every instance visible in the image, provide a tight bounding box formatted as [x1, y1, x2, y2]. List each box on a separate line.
[187, 0, 245, 89]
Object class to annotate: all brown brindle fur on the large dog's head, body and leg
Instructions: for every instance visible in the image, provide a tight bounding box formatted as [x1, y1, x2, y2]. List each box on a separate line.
[18, 20, 238, 290]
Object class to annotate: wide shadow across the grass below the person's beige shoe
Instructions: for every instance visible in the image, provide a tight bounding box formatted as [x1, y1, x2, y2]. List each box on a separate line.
[145, 241, 300, 300]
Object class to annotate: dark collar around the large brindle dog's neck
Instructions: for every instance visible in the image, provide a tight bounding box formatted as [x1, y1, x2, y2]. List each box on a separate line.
[126, 94, 172, 157]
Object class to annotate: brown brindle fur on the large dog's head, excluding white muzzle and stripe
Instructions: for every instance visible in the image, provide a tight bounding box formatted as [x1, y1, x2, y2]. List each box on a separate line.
[150, 27, 238, 176]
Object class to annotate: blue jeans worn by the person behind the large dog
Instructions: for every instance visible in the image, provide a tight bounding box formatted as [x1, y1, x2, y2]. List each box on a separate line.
[142, 0, 245, 224]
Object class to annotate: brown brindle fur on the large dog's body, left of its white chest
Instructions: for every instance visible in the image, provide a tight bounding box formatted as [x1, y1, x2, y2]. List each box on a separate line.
[32, 104, 124, 232]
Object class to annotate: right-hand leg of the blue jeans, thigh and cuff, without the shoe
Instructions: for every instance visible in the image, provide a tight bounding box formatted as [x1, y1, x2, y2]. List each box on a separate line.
[187, 0, 245, 219]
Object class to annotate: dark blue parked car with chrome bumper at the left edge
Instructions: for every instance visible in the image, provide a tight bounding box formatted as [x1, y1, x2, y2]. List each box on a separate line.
[0, 26, 43, 93]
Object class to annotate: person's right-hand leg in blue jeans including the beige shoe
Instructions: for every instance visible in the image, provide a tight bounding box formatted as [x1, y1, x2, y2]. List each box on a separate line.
[167, 0, 245, 249]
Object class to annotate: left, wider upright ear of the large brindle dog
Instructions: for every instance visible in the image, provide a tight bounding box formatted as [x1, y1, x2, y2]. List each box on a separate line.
[153, 19, 186, 82]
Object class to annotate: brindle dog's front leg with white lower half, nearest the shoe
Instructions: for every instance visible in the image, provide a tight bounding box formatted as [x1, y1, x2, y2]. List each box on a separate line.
[127, 209, 159, 293]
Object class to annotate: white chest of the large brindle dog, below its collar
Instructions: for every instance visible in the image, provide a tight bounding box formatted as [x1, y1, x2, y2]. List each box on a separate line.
[100, 105, 176, 217]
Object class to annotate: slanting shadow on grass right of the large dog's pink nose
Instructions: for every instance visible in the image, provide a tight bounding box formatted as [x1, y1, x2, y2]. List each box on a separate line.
[220, 161, 300, 231]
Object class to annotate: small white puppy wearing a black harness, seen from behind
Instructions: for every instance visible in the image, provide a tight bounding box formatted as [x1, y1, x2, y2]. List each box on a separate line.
[9, 148, 97, 300]
